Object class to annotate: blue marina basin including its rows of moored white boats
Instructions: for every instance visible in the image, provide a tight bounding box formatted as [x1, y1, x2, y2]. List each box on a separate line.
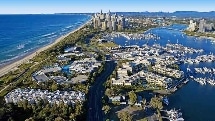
[111, 25, 215, 121]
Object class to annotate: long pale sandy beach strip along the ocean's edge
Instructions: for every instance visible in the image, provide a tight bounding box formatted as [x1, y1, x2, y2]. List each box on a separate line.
[0, 18, 92, 77]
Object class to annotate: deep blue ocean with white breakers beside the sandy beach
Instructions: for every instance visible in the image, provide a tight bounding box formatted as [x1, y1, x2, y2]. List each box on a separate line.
[0, 14, 91, 66]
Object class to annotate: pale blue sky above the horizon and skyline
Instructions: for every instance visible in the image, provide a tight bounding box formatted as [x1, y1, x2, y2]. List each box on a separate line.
[0, 0, 215, 14]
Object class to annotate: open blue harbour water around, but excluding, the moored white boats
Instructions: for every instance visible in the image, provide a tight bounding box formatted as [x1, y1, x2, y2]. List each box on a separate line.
[114, 24, 215, 121]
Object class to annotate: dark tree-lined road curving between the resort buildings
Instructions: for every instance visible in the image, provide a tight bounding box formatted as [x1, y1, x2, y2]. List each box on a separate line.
[87, 61, 116, 121]
